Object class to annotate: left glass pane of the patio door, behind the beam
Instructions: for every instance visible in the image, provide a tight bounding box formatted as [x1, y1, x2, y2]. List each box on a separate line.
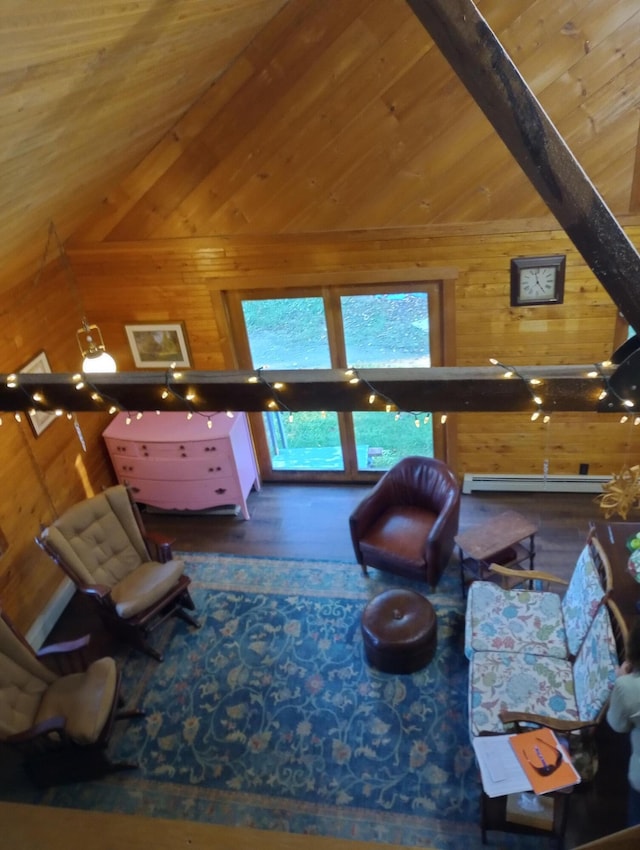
[242, 298, 344, 471]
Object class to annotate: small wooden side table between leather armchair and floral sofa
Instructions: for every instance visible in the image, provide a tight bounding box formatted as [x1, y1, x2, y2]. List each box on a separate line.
[455, 511, 538, 596]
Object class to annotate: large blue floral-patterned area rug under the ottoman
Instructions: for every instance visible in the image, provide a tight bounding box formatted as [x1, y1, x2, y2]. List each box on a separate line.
[3, 553, 540, 850]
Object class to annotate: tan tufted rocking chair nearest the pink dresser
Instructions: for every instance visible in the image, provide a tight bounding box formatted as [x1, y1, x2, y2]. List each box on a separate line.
[36, 485, 198, 661]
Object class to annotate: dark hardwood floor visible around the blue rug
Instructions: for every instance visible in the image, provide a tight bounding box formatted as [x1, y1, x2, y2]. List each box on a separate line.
[50, 484, 628, 848]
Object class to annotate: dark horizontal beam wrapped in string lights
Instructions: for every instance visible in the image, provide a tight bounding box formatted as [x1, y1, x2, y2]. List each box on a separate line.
[0, 366, 629, 413]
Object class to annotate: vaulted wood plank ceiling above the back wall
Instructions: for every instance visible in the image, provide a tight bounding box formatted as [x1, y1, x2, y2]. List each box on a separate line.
[5, 0, 640, 288]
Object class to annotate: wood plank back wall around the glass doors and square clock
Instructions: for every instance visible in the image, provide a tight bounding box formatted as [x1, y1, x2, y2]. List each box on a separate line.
[71, 215, 640, 475]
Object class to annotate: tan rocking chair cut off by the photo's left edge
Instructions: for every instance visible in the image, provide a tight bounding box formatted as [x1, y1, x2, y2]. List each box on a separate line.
[0, 611, 142, 786]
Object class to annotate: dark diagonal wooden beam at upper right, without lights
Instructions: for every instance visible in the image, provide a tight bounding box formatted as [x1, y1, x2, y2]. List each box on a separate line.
[407, 0, 640, 331]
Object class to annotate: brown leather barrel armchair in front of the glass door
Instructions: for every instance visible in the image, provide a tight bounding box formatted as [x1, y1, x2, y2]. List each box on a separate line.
[349, 456, 460, 587]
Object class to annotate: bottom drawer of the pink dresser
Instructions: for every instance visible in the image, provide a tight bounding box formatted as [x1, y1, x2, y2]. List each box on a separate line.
[127, 478, 243, 511]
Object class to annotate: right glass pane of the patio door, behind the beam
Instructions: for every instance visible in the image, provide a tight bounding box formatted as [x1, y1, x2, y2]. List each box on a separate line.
[340, 292, 433, 470]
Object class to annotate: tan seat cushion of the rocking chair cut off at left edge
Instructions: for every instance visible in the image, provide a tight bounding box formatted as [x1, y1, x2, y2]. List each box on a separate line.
[35, 658, 118, 744]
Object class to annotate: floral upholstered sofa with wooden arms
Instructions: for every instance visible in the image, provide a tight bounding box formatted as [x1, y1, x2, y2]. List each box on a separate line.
[465, 538, 623, 737]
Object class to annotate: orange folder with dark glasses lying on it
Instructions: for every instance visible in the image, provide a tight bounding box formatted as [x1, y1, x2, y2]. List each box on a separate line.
[509, 729, 580, 794]
